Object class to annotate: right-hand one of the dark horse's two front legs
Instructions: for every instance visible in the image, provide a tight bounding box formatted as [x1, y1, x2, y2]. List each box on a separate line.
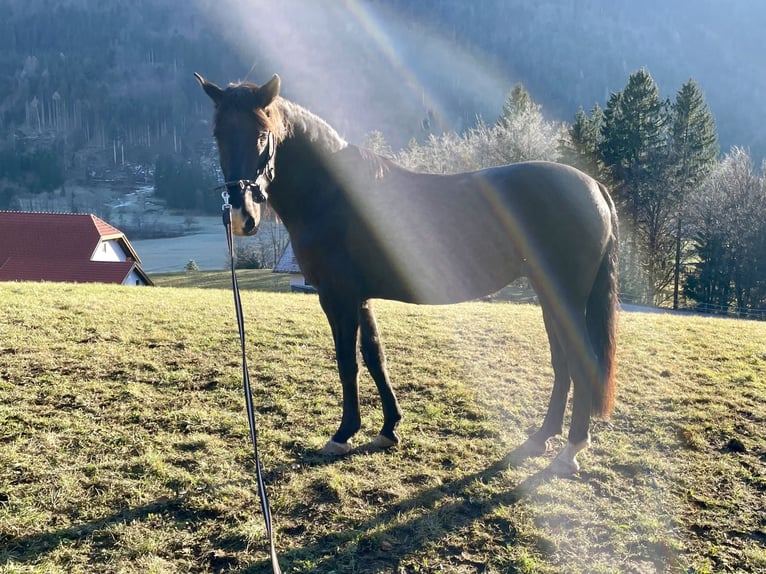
[359, 301, 402, 448]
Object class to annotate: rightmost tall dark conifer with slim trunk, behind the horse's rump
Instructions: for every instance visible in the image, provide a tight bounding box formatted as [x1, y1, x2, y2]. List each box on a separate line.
[670, 79, 719, 309]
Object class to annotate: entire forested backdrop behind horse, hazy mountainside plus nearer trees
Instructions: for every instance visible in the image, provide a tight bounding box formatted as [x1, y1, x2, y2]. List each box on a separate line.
[0, 0, 766, 314]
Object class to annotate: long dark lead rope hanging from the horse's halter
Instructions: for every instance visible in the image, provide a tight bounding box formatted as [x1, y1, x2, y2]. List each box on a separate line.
[221, 191, 282, 574]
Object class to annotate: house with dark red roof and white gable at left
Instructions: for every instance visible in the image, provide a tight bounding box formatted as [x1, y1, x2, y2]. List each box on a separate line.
[0, 211, 153, 285]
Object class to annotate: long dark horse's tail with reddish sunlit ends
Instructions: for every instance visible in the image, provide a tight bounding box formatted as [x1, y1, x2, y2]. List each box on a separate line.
[586, 183, 618, 417]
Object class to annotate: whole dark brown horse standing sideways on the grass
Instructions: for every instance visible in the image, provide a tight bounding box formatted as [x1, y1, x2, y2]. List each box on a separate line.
[195, 73, 618, 474]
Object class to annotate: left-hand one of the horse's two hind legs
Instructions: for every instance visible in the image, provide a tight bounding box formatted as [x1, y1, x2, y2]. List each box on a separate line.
[522, 307, 571, 456]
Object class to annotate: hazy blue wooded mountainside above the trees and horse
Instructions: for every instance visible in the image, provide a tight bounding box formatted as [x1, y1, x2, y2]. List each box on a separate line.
[0, 0, 766, 214]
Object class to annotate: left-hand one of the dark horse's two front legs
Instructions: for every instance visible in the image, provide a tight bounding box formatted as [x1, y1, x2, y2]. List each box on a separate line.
[319, 294, 362, 455]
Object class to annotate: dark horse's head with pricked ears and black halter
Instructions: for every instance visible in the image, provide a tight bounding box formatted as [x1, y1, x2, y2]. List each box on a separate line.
[194, 74, 280, 235]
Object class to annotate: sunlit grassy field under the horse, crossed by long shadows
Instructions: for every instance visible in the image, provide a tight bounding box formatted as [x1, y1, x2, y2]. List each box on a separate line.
[0, 283, 766, 574]
